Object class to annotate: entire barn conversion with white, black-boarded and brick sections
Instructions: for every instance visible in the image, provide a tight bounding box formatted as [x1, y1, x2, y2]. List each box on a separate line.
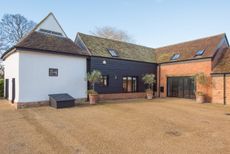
[2, 13, 230, 108]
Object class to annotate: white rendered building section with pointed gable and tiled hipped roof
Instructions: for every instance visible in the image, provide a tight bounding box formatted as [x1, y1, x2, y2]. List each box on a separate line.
[2, 13, 87, 108]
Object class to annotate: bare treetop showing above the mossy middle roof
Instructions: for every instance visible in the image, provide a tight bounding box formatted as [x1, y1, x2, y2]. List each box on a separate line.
[91, 26, 133, 42]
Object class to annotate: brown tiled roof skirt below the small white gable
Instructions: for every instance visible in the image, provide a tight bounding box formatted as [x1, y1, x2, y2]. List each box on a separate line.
[15, 31, 87, 55]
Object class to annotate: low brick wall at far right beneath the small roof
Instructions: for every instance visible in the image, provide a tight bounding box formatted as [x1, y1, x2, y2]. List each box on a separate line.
[212, 75, 230, 104]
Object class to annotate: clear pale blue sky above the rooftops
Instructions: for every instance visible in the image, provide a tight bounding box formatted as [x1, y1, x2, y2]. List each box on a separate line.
[0, 0, 230, 47]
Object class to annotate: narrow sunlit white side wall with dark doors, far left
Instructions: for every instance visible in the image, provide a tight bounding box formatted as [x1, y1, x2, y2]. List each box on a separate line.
[3, 52, 19, 102]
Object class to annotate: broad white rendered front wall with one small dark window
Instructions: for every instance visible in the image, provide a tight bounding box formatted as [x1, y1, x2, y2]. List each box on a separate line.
[18, 51, 87, 103]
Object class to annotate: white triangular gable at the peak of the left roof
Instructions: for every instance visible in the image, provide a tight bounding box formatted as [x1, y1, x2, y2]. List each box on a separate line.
[35, 14, 67, 37]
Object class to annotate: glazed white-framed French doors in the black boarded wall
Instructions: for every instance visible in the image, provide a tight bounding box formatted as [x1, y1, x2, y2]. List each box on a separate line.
[123, 76, 138, 92]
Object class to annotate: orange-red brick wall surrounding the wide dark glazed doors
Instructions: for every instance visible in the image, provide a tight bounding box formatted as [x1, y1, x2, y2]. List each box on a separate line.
[158, 59, 212, 102]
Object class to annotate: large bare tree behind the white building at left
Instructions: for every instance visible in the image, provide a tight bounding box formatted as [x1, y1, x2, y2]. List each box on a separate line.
[0, 14, 35, 53]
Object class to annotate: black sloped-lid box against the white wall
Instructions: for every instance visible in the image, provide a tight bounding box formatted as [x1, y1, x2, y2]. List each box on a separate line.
[49, 94, 75, 108]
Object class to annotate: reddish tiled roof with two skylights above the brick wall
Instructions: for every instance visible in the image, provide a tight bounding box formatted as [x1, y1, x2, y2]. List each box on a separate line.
[155, 34, 225, 63]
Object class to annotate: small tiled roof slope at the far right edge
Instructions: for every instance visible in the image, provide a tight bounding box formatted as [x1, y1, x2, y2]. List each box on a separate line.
[213, 48, 230, 73]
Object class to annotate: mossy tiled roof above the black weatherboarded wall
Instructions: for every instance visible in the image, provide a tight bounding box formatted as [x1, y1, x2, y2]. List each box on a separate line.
[78, 33, 156, 63]
